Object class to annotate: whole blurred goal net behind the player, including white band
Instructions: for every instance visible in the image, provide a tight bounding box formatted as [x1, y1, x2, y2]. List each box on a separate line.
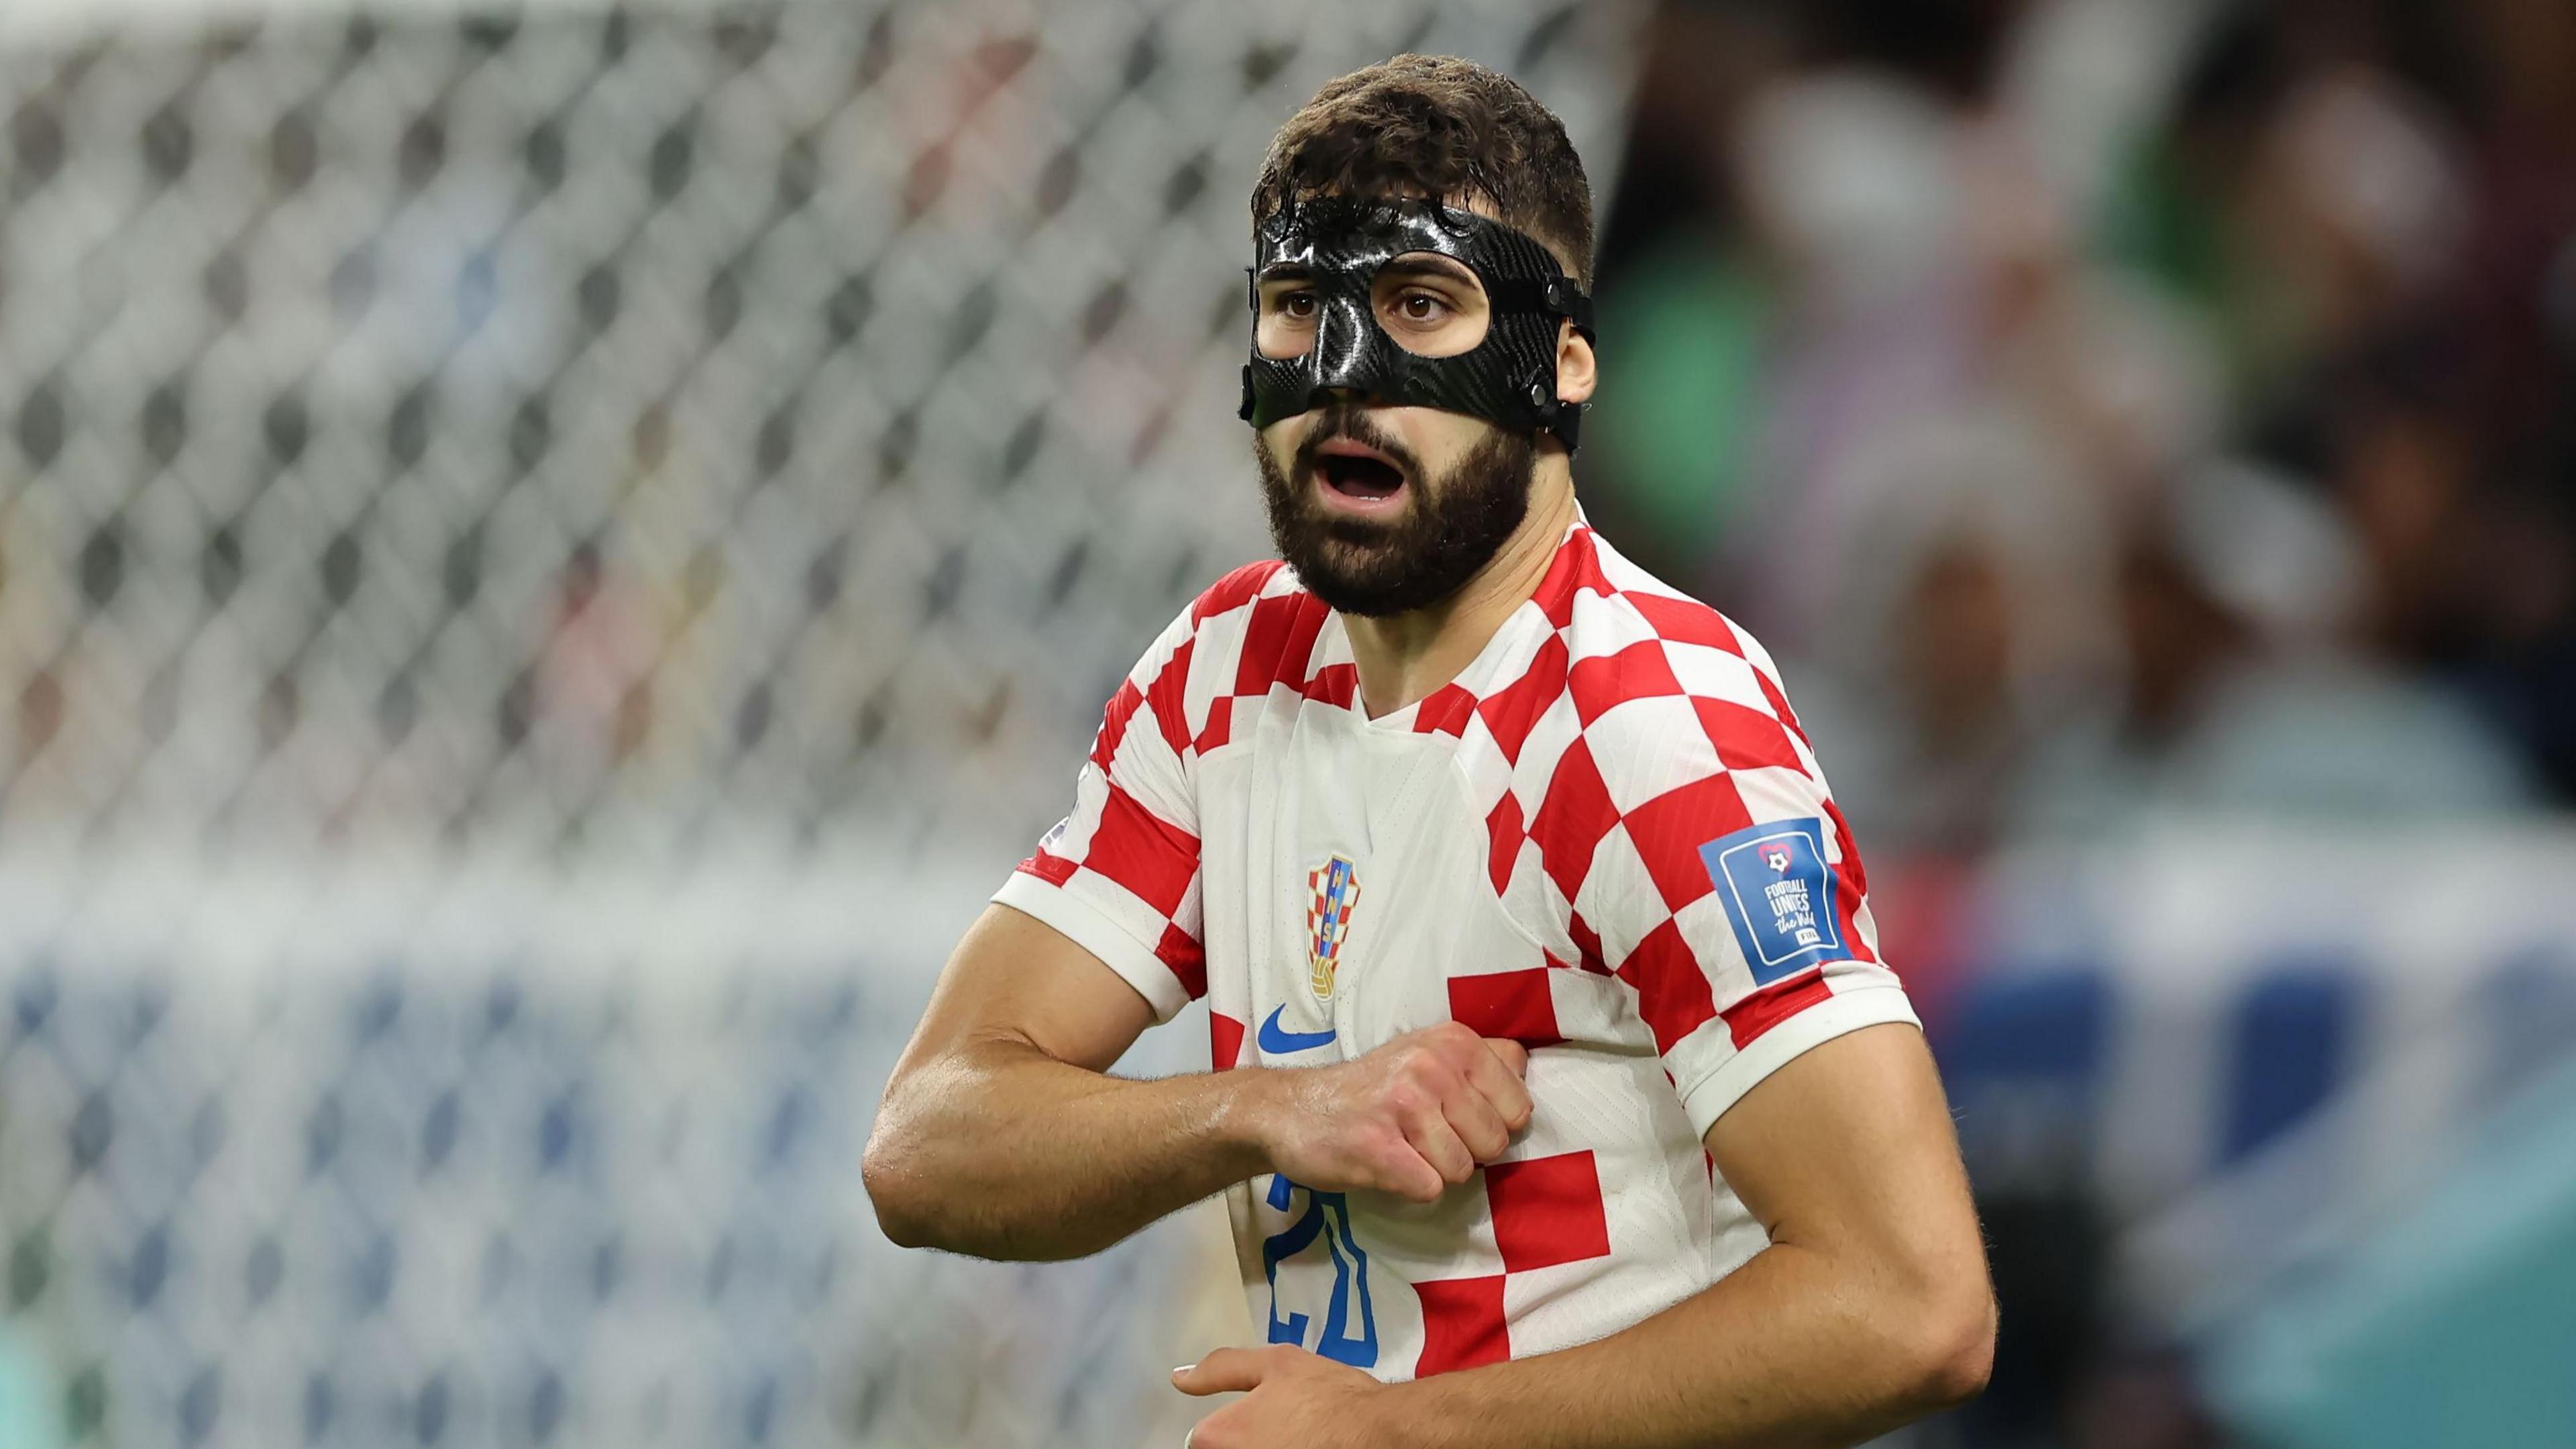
[0, 0, 1625, 1446]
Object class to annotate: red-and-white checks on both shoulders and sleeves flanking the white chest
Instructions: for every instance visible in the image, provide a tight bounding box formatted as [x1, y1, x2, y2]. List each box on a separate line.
[1005, 526, 1896, 1129]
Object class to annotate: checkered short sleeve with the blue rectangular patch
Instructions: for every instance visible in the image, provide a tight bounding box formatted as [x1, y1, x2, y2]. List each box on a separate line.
[1556, 598, 1917, 1134]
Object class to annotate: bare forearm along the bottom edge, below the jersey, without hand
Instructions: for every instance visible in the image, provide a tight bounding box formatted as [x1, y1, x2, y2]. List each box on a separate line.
[1393, 1227, 1991, 1449]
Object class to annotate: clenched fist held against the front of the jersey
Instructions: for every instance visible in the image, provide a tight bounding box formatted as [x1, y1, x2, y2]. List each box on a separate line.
[1247, 1021, 1530, 1201]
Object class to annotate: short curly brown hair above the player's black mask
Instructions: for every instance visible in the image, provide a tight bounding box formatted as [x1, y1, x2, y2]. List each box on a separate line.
[1252, 54, 1592, 288]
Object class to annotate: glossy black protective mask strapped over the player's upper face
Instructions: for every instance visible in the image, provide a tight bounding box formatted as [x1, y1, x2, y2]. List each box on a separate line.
[1242, 196, 1592, 451]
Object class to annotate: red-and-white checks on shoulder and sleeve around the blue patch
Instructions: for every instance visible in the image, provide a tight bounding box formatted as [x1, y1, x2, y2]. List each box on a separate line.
[1453, 526, 1896, 1132]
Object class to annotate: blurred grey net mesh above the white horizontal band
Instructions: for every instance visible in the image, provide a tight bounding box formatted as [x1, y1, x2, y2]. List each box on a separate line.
[0, 3, 1638, 851]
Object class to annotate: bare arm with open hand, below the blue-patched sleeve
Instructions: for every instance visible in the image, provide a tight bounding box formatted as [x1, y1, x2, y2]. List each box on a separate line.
[1180, 1024, 1994, 1449]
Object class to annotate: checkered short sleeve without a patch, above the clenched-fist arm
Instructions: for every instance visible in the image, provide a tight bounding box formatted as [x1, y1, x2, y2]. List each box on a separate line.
[994, 598, 1208, 1021]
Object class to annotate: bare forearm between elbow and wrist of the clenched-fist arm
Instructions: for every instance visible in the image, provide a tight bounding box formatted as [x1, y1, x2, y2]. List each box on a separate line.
[865, 1039, 1267, 1260]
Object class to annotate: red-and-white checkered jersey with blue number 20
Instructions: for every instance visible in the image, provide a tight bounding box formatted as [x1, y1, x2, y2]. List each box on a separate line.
[994, 523, 1914, 1379]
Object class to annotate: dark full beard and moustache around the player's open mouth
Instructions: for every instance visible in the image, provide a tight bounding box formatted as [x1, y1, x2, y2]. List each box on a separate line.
[1252, 405, 1538, 619]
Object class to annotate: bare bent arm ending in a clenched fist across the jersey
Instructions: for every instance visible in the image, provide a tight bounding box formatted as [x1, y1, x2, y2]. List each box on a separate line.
[861, 905, 1530, 1258]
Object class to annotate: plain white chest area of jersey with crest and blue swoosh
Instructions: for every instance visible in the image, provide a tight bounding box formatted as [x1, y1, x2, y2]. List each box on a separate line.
[1200, 706, 1536, 1065]
